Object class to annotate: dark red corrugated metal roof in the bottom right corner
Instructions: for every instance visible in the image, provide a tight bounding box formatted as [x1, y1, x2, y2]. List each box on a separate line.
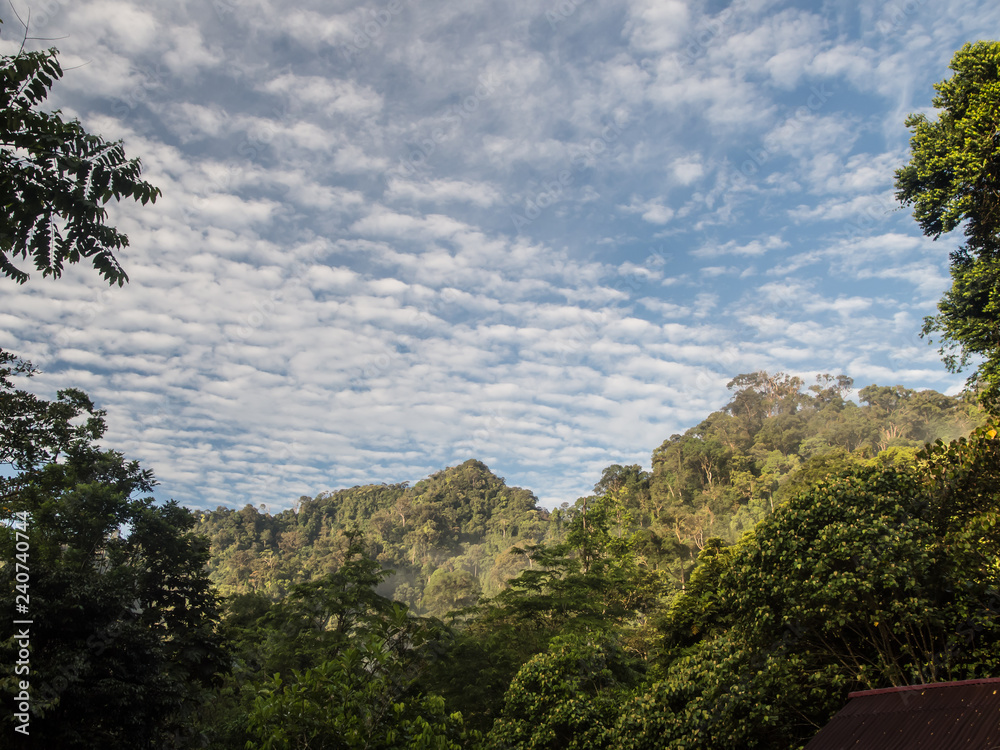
[806, 678, 1000, 750]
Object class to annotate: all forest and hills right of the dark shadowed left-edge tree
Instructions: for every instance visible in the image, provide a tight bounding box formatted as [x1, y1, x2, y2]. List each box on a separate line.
[174, 372, 1000, 750]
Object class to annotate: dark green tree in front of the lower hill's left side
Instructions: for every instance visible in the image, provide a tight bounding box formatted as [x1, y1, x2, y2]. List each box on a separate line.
[199, 530, 474, 750]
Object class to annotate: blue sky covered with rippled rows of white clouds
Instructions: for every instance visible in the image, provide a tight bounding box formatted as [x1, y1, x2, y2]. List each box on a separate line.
[0, 0, 1000, 511]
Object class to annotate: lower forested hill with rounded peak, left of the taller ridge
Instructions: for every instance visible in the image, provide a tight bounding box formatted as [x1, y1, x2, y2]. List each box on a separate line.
[191, 460, 549, 615]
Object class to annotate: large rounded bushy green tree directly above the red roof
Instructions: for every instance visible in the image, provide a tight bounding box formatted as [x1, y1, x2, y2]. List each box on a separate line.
[722, 462, 1000, 688]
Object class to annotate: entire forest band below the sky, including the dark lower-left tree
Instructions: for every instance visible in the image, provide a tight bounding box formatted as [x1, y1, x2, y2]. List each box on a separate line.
[0, 354, 1000, 750]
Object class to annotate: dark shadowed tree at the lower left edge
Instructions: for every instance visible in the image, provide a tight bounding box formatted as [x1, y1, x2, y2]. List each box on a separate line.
[0, 352, 223, 748]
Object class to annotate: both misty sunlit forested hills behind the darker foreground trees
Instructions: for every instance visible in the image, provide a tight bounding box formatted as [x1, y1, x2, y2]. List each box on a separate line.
[196, 372, 982, 615]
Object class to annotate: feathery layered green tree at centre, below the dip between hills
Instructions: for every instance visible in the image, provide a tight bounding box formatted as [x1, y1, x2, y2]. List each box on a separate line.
[436, 493, 668, 742]
